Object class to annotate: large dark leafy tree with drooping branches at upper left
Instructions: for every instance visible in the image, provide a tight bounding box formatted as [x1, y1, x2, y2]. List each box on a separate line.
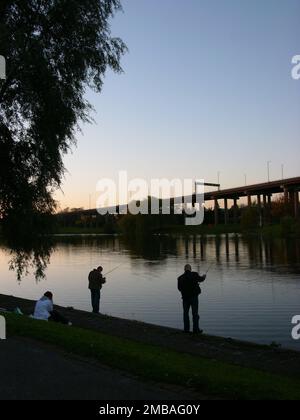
[0, 0, 126, 278]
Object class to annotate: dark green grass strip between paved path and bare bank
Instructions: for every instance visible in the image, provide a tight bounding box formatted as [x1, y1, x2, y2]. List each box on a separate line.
[5, 314, 300, 400]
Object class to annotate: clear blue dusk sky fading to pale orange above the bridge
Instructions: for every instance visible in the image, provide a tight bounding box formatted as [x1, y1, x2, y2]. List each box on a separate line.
[55, 0, 300, 209]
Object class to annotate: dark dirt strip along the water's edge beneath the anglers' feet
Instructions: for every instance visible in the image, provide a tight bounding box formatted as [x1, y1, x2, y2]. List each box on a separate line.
[0, 295, 300, 378]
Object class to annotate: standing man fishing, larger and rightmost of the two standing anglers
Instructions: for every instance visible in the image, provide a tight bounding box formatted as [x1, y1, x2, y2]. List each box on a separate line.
[178, 264, 206, 334]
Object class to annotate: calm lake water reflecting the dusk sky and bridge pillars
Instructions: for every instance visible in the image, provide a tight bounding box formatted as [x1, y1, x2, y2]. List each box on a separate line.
[0, 235, 300, 350]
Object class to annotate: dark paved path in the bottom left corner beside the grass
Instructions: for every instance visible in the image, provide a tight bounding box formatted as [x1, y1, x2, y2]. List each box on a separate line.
[0, 338, 195, 400]
